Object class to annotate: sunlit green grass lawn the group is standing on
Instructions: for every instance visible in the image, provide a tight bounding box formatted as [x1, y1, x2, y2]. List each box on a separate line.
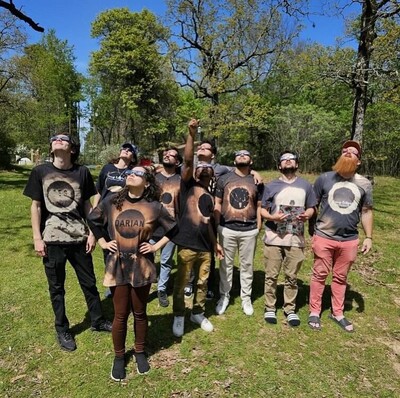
[0, 169, 400, 398]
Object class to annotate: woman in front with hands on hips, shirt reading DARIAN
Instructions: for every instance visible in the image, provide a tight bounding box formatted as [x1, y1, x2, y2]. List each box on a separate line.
[88, 166, 176, 381]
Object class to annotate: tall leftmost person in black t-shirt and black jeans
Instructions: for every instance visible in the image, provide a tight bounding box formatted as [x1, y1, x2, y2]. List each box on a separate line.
[23, 134, 111, 351]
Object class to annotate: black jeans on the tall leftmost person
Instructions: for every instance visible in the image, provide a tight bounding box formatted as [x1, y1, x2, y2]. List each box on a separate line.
[43, 243, 103, 332]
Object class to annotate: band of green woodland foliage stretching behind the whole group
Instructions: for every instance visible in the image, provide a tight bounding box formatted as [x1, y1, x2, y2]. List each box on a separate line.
[0, 0, 400, 175]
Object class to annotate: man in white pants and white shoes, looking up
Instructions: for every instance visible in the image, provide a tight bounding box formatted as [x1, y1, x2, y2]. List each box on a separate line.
[214, 150, 264, 316]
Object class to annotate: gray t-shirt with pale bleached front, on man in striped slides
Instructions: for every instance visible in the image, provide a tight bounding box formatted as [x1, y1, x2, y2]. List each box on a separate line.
[261, 177, 317, 247]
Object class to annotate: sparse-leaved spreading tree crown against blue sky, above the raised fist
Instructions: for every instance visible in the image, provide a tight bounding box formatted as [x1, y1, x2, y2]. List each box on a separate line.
[167, 0, 299, 129]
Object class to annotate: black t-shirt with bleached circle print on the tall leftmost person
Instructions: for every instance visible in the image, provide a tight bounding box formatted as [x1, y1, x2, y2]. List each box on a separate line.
[23, 163, 96, 244]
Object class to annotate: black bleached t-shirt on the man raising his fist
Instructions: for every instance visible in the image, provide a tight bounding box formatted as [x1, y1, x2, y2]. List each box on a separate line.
[172, 178, 214, 252]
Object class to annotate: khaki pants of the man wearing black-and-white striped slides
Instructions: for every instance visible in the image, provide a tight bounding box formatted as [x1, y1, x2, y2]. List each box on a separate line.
[264, 245, 304, 314]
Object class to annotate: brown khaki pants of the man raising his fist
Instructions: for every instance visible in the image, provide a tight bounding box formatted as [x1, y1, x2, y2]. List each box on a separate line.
[173, 246, 211, 316]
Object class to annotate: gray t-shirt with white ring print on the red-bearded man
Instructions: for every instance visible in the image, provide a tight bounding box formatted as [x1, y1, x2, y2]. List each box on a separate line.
[314, 171, 373, 241]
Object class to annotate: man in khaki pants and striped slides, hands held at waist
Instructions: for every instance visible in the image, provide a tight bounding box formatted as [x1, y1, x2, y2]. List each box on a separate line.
[261, 150, 317, 326]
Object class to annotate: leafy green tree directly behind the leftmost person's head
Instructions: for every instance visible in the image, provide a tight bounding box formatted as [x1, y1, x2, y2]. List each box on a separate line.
[12, 30, 82, 151]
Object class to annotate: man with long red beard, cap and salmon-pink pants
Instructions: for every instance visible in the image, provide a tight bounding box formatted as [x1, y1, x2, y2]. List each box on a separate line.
[308, 141, 373, 332]
